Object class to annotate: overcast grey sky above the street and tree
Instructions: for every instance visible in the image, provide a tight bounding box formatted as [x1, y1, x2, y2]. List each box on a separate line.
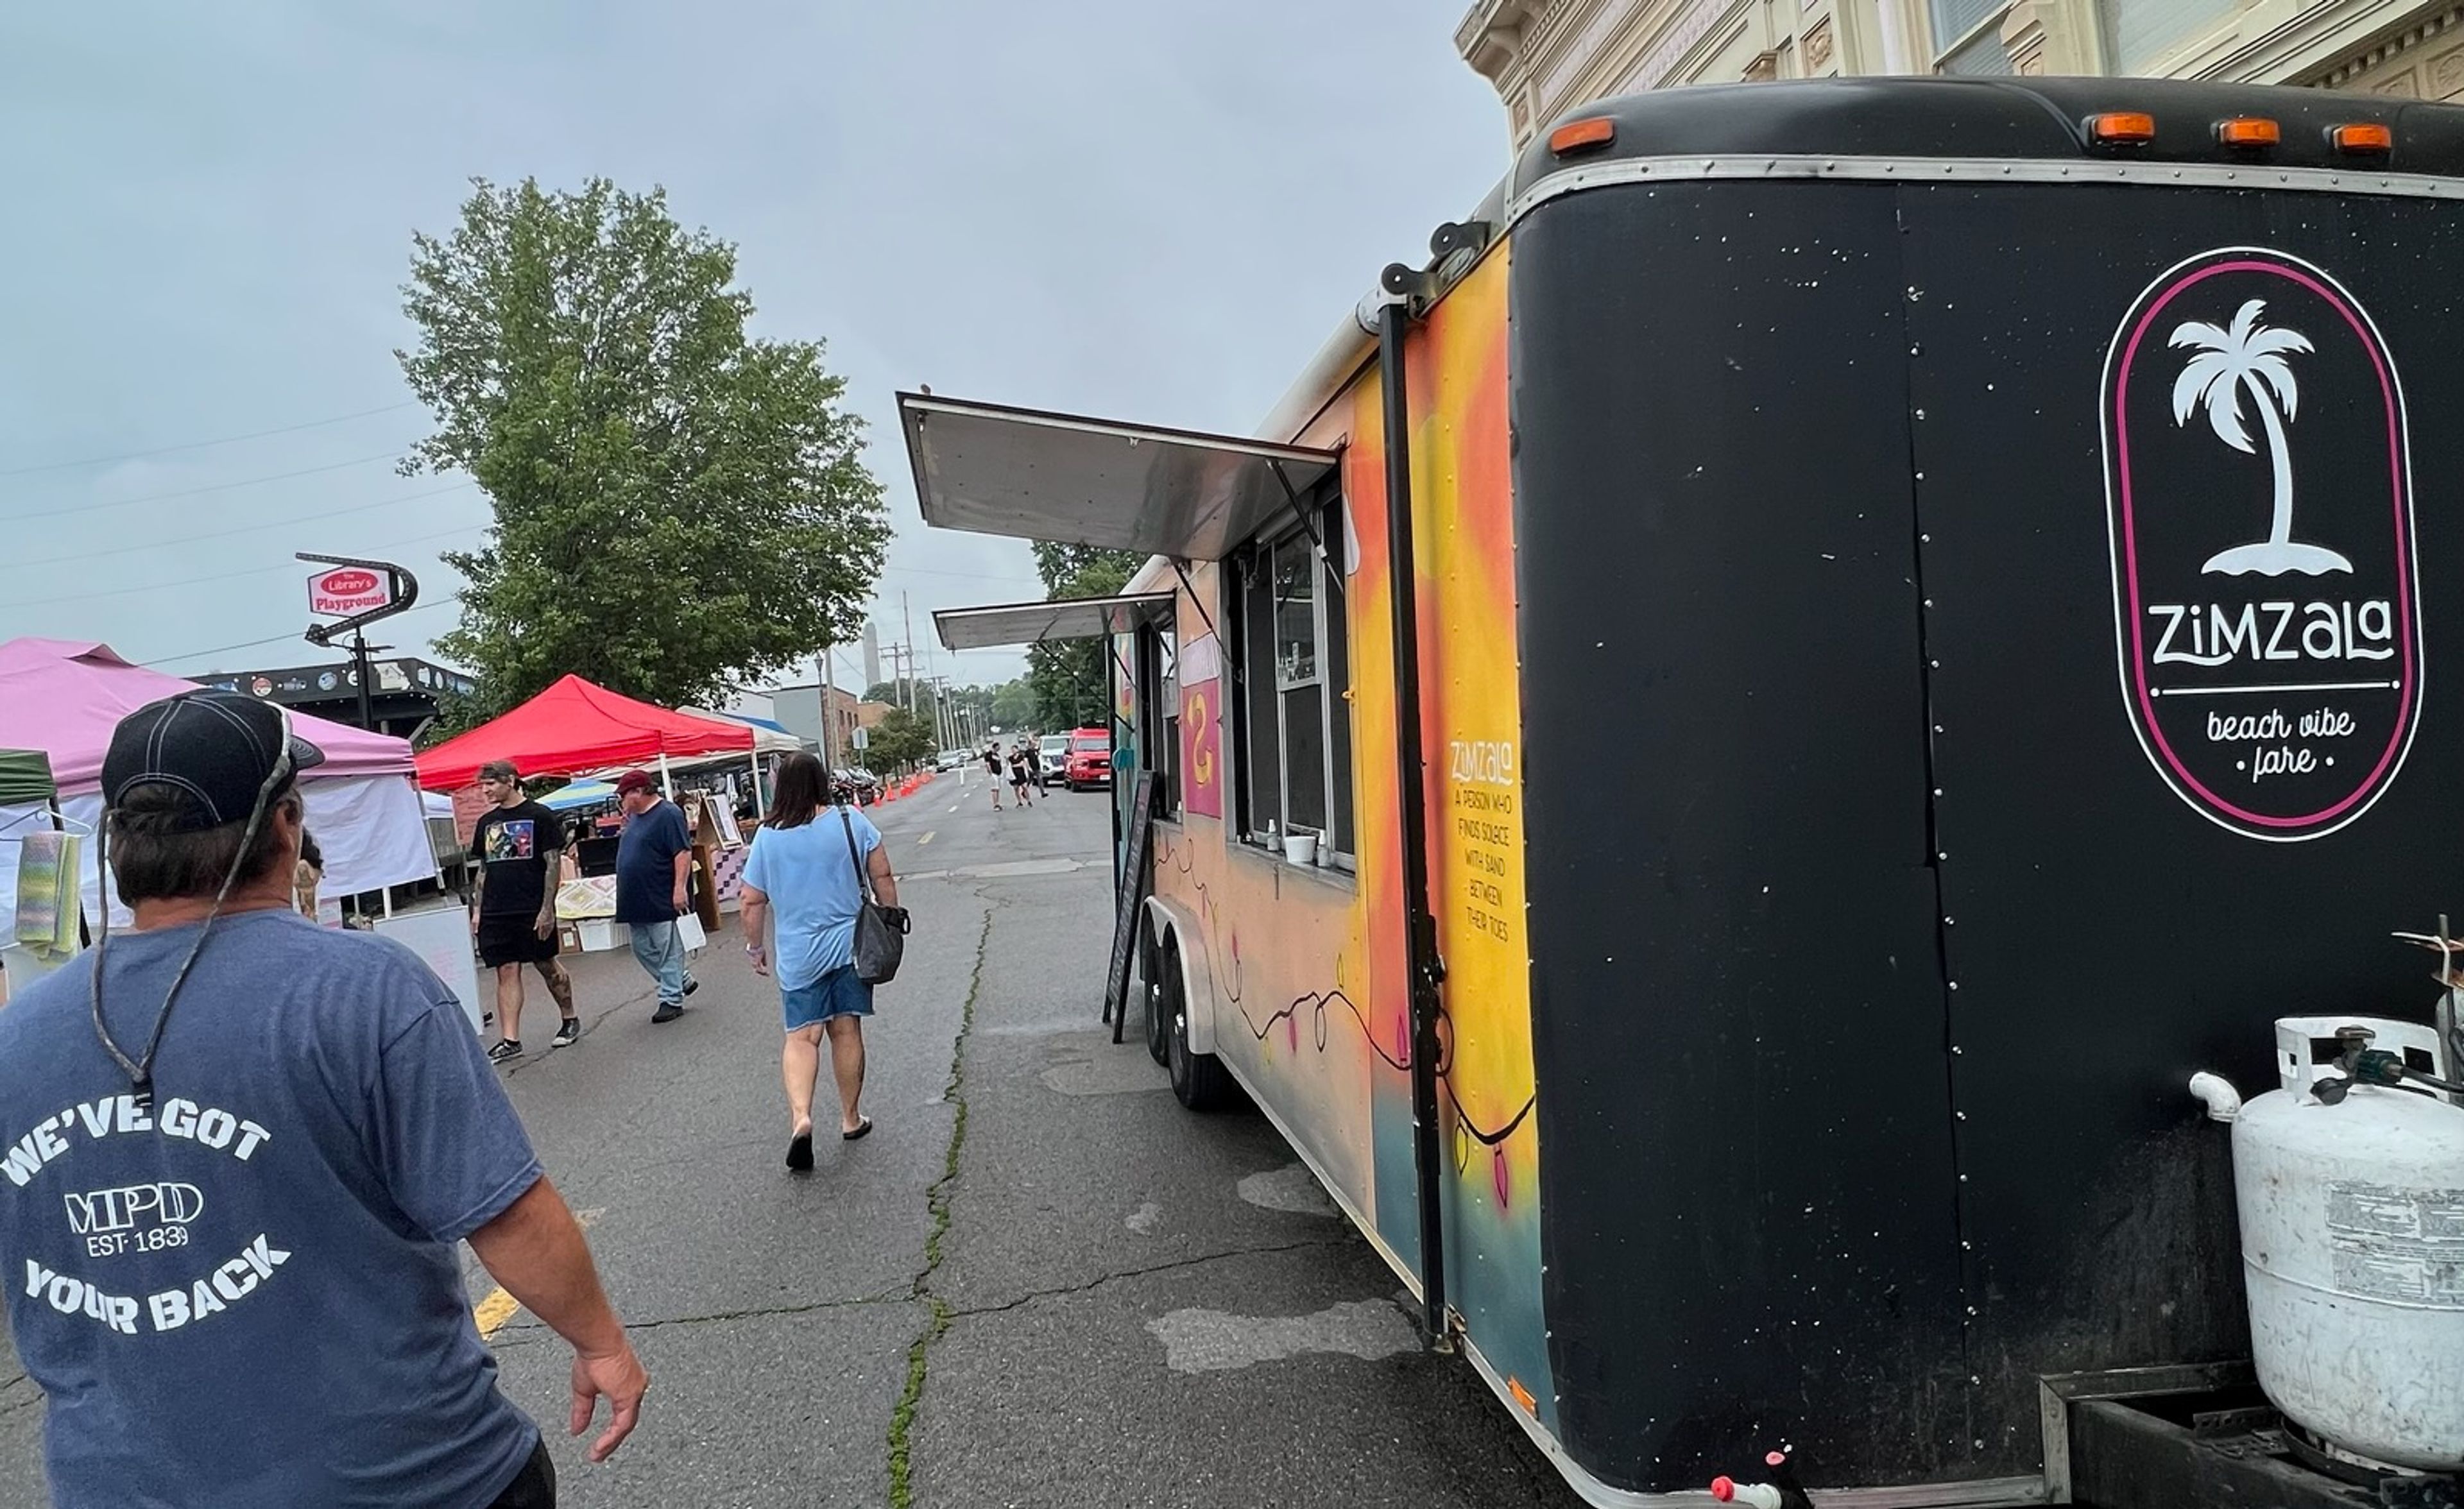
[0, 0, 1508, 700]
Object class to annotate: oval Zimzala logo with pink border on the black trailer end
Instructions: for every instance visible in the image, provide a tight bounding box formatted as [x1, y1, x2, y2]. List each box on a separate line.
[2102, 246, 2422, 841]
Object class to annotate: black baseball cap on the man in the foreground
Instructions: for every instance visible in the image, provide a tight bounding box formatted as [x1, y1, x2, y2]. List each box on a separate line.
[103, 690, 325, 831]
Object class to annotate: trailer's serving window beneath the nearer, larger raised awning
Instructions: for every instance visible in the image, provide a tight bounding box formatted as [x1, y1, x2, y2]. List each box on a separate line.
[1232, 500, 1353, 868]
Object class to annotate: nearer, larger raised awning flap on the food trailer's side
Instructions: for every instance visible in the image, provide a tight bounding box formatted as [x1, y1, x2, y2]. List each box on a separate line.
[900, 392, 1338, 559]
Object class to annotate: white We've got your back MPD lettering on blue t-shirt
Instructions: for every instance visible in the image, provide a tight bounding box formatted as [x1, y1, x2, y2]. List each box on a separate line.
[0, 1095, 291, 1336]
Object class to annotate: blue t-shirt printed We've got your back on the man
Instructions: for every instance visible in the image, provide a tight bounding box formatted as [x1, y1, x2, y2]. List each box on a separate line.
[0, 910, 540, 1509]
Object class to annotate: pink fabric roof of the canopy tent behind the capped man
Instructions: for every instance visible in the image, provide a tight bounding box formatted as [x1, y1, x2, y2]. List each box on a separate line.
[0, 638, 411, 796]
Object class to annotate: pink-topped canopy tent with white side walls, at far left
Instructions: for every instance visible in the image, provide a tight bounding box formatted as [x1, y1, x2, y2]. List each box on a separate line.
[0, 638, 436, 915]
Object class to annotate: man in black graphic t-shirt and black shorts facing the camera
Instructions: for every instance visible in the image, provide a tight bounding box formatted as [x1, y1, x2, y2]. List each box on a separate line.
[470, 760, 581, 1062]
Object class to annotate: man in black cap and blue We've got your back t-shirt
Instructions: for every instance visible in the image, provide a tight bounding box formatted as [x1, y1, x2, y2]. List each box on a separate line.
[0, 690, 651, 1509]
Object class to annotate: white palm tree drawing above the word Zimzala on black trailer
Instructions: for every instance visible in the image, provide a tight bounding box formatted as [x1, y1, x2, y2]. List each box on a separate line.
[2166, 298, 2353, 577]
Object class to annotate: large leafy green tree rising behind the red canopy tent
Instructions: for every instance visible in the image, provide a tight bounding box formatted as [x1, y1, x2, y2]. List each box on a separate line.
[394, 180, 889, 715]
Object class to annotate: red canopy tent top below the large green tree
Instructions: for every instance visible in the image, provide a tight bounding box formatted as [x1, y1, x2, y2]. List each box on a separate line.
[419, 676, 754, 792]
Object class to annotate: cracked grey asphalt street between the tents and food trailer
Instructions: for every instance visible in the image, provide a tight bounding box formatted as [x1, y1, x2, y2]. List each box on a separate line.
[0, 774, 1577, 1509]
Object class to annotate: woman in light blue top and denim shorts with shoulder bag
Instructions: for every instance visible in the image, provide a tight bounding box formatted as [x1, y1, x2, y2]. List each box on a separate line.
[742, 754, 902, 1173]
